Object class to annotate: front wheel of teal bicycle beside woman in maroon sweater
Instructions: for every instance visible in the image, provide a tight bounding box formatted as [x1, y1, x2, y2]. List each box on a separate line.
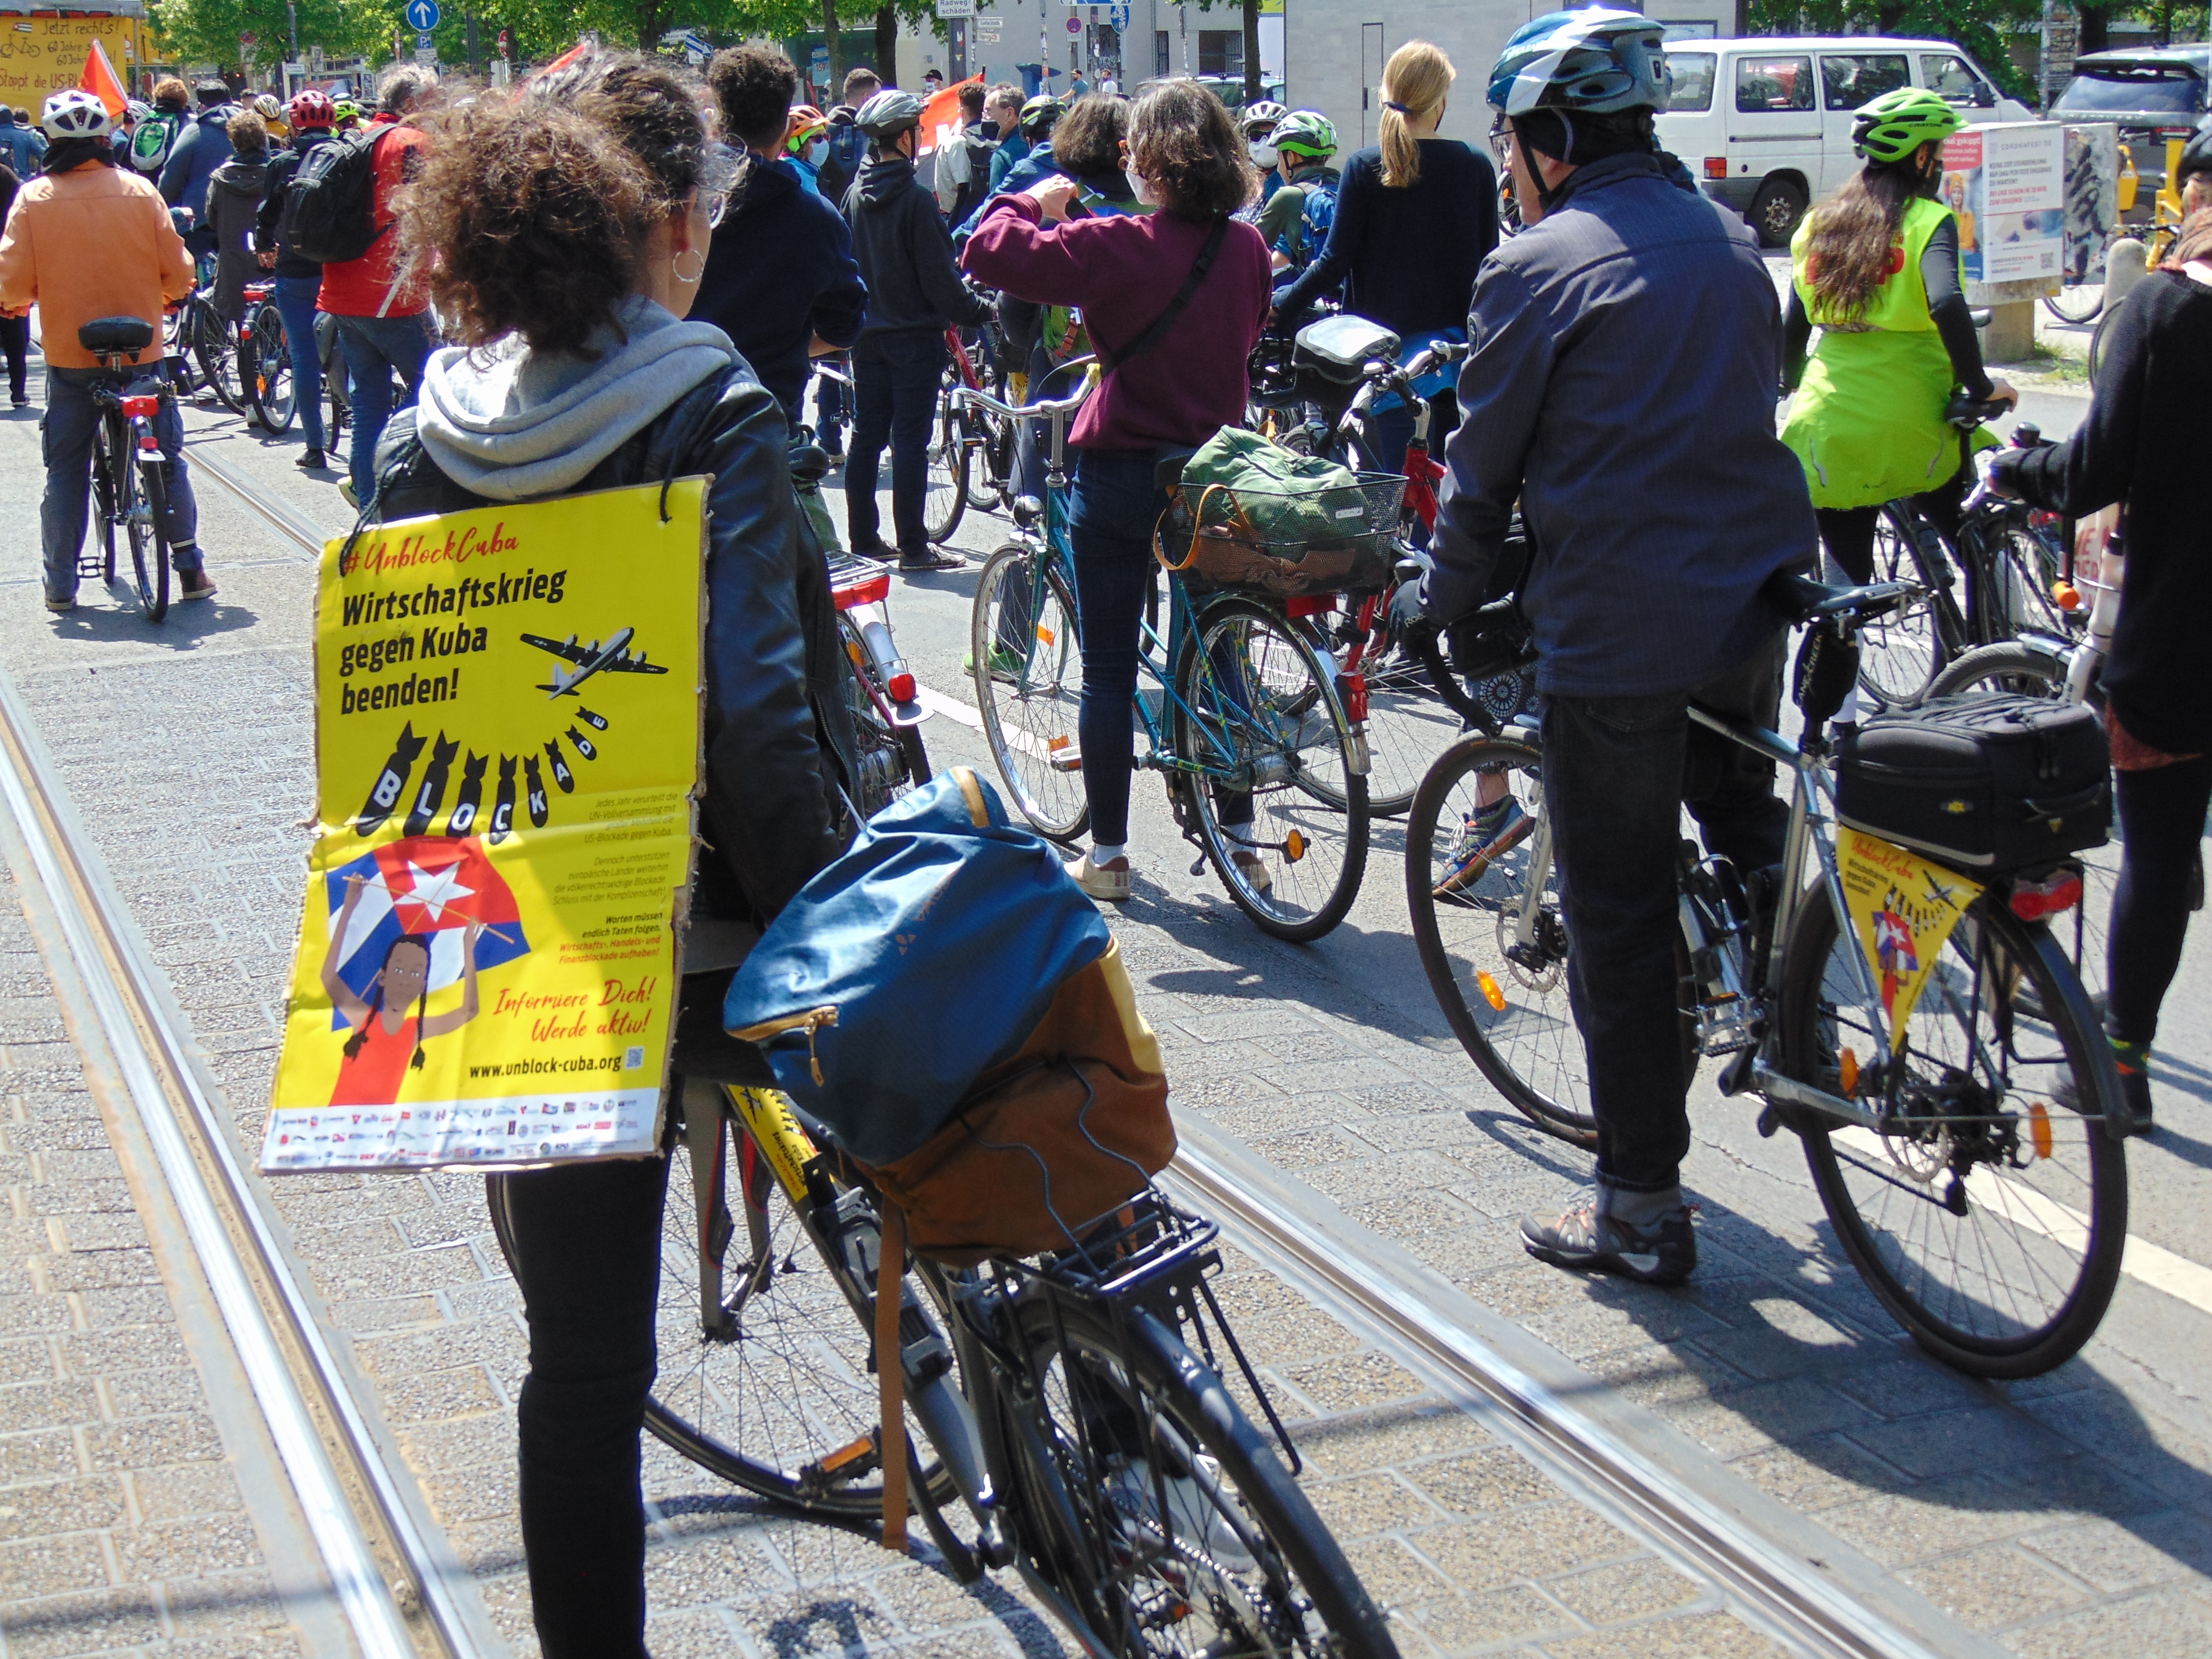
[969, 542, 1091, 843]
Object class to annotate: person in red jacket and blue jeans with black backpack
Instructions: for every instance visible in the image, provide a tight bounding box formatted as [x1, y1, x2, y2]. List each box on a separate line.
[316, 64, 438, 507]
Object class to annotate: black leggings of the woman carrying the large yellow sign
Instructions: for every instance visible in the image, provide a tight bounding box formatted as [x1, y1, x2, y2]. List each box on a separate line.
[491, 1157, 668, 1659]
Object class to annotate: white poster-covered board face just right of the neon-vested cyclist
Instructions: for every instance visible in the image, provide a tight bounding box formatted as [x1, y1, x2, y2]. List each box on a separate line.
[1942, 122, 2066, 305]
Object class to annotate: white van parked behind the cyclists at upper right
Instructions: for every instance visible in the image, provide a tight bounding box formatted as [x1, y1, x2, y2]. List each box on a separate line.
[1659, 35, 2035, 248]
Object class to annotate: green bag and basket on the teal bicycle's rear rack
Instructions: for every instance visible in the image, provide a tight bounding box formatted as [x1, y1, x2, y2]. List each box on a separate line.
[1152, 427, 1405, 597]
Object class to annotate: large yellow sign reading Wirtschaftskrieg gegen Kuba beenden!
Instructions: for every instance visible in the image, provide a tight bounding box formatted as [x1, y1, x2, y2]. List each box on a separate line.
[261, 478, 705, 1173]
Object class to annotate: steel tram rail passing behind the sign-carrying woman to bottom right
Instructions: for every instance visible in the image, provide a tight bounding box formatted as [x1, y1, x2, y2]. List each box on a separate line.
[181, 418, 1997, 1659]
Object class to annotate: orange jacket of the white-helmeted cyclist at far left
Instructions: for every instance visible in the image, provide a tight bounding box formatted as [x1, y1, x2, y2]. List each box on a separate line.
[0, 161, 192, 369]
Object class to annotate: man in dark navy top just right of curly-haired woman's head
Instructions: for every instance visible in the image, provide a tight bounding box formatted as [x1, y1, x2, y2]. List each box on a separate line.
[690, 46, 867, 431]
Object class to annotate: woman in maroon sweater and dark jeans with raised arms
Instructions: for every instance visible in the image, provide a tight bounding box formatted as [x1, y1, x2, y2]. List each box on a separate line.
[964, 79, 1270, 900]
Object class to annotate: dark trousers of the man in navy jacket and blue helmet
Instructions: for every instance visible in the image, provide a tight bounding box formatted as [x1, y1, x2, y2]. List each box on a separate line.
[1544, 628, 1790, 1192]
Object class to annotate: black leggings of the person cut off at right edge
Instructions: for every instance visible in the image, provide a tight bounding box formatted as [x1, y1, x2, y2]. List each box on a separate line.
[2106, 757, 2212, 1044]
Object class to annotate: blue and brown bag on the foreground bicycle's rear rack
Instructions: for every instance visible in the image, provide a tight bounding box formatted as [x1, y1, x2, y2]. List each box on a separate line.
[723, 768, 1175, 1263]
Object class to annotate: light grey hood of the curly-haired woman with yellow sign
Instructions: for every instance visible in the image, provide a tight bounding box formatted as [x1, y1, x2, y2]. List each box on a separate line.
[416, 294, 739, 502]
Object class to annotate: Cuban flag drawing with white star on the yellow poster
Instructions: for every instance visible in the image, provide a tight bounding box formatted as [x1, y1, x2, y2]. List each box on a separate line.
[323, 836, 531, 1031]
